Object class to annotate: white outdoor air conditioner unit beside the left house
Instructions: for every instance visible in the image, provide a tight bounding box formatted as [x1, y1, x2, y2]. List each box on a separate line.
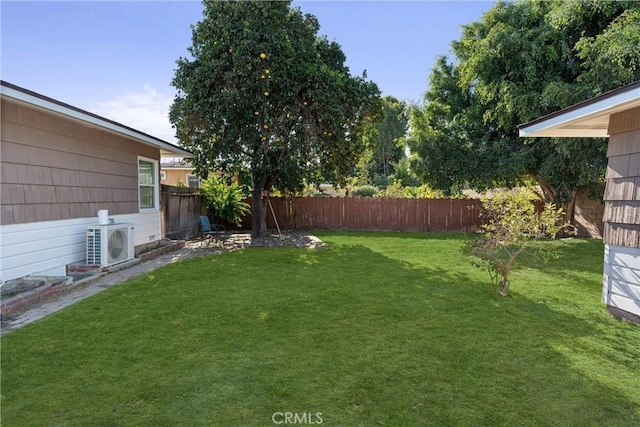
[87, 223, 135, 267]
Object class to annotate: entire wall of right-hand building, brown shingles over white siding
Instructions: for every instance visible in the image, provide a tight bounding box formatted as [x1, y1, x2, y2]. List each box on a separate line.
[603, 108, 640, 318]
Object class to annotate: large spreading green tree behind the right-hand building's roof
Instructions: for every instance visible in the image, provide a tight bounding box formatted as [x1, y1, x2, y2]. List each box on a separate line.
[409, 0, 640, 224]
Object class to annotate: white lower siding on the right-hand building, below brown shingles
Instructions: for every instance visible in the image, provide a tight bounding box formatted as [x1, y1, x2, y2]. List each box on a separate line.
[602, 245, 640, 316]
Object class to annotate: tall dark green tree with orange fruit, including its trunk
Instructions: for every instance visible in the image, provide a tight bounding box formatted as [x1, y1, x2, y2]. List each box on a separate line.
[170, 1, 380, 237]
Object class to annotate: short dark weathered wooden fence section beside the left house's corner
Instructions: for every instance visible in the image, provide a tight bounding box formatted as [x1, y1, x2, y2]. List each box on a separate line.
[160, 185, 207, 239]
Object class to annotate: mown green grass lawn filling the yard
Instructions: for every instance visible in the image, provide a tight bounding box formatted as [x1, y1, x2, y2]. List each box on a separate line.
[1, 232, 640, 427]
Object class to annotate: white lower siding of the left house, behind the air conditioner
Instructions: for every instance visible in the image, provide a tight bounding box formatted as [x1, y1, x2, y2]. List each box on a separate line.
[0, 211, 162, 280]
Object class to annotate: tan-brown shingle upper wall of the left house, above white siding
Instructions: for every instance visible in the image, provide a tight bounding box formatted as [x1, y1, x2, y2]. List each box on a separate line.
[0, 99, 159, 225]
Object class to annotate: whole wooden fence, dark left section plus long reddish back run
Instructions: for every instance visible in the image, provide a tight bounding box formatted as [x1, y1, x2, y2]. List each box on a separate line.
[161, 191, 481, 239]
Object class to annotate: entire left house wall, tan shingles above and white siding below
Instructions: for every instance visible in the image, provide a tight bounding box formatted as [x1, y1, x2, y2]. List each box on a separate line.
[0, 96, 162, 280]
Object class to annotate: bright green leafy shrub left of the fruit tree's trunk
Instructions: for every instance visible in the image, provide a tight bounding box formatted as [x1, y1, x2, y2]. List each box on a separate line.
[201, 174, 249, 226]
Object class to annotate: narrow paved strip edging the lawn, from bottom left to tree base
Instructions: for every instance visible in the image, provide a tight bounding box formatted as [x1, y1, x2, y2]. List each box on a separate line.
[1, 231, 324, 335]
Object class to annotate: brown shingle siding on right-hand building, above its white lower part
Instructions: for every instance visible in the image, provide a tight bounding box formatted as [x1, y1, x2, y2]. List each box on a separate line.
[603, 108, 640, 248]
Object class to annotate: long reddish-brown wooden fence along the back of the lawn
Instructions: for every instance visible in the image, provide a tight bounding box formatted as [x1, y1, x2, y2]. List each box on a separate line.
[252, 197, 481, 231]
